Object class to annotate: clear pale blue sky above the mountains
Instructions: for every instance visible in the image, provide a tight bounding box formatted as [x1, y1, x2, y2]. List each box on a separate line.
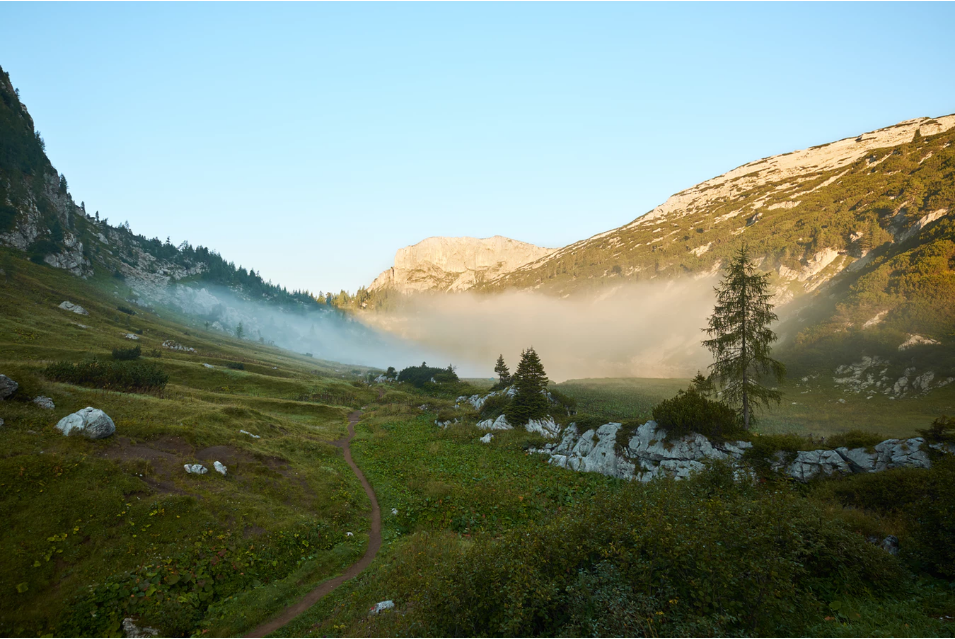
[0, 3, 955, 291]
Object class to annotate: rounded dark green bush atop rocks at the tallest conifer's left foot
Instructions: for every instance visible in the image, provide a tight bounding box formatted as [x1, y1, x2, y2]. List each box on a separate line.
[653, 386, 743, 441]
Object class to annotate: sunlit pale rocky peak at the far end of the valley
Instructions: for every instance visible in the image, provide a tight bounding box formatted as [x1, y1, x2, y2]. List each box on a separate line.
[368, 235, 554, 293]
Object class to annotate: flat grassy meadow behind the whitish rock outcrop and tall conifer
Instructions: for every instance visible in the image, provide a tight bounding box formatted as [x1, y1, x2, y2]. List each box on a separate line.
[556, 376, 955, 438]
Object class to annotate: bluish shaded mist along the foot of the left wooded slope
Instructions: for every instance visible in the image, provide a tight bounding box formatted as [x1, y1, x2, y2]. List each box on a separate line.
[128, 285, 450, 369]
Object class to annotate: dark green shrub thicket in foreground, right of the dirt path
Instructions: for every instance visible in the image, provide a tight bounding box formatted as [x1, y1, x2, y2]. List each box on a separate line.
[386, 468, 906, 637]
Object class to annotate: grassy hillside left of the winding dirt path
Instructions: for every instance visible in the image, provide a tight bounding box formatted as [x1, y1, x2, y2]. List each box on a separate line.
[0, 255, 384, 635]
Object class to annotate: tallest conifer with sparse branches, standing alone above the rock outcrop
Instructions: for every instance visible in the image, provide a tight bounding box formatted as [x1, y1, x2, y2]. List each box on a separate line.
[703, 245, 786, 429]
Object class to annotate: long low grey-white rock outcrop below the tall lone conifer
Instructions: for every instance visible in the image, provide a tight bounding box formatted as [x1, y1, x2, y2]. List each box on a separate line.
[535, 421, 953, 482]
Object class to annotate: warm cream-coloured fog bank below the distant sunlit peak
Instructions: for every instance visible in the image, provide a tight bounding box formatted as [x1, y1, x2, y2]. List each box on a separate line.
[361, 278, 717, 381]
